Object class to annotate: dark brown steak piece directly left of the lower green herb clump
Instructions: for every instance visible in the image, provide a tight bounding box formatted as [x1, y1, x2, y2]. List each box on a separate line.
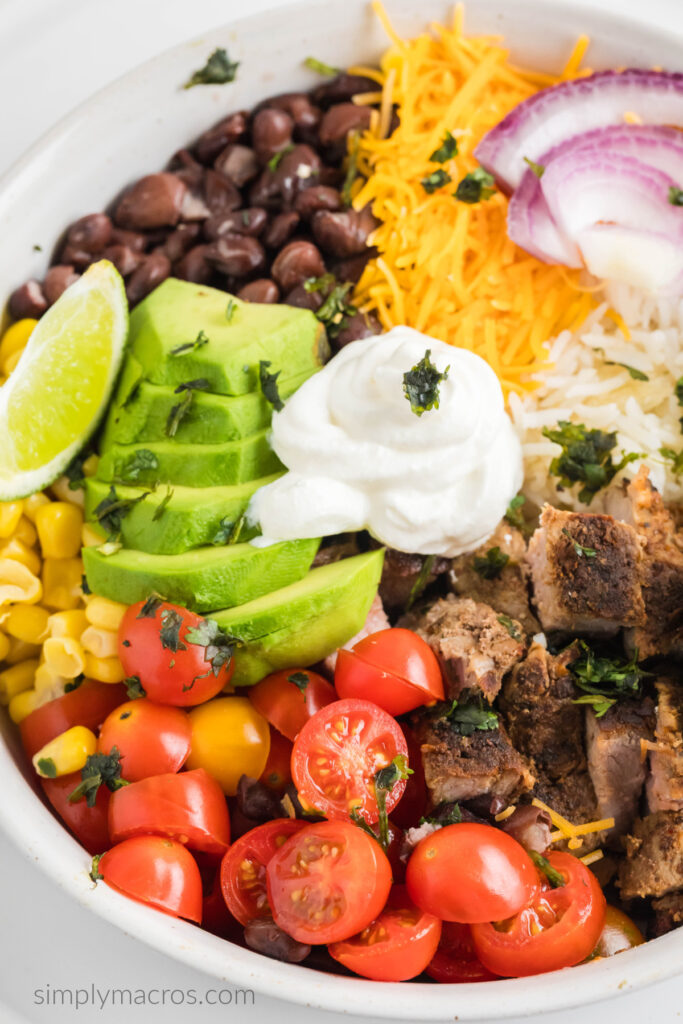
[501, 644, 586, 782]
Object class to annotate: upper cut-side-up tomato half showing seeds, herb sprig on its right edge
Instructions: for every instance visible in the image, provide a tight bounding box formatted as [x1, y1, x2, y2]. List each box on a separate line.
[292, 699, 408, 823]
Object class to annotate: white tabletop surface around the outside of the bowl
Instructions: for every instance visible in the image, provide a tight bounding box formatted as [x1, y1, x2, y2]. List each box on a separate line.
[0, 0, 683, 1024]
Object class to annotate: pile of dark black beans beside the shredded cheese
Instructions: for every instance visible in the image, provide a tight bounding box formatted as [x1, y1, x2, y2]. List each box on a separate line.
[9, 74, 380, 348]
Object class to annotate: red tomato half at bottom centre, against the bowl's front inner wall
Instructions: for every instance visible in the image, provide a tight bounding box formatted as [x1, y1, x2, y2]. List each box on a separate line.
[329, 886, 441, 981]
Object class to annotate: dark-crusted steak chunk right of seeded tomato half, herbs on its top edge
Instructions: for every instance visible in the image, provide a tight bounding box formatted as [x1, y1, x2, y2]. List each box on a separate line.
[415, 714, 535, 806]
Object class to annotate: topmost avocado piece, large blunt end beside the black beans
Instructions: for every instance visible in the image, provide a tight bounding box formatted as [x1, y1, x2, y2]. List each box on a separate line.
[129, 278, 330, 395]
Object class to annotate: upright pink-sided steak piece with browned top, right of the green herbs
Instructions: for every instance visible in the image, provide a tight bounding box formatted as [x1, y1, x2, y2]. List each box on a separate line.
[586, 697, 654, 843]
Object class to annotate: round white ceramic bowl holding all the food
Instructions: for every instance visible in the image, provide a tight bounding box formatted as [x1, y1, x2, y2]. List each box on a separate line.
[0, 0, 683, 1021]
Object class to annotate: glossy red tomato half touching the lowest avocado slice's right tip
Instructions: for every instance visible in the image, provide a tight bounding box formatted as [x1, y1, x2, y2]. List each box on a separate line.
[335, 629, 443, 715]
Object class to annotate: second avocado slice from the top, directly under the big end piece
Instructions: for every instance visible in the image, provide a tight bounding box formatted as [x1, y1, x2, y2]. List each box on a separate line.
[101, 371, 310, 451]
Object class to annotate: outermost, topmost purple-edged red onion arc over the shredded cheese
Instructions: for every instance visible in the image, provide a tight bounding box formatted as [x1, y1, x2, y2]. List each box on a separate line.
[475, 69, 683, 193]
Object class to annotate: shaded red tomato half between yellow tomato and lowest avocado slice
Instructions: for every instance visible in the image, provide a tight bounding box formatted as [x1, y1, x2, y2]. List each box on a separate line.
[249, 669, 337, 741]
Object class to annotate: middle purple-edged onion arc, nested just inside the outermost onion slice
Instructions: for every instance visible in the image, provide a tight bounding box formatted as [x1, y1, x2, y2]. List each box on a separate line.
[508, 124, 683, 267]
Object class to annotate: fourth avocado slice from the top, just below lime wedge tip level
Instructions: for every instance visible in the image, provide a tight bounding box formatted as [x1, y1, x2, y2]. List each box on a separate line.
[85, 473, 281, 555]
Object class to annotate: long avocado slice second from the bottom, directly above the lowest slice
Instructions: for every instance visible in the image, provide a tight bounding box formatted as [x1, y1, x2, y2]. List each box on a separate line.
[83, 539, 321, 612]
